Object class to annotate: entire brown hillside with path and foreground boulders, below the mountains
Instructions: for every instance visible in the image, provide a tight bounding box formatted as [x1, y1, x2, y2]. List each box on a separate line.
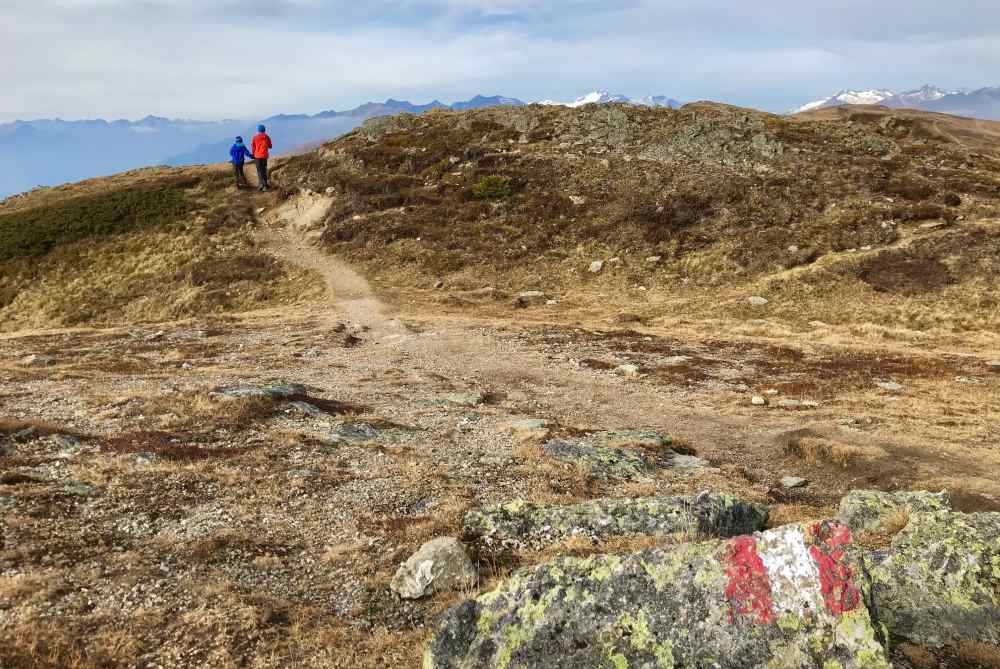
[0, 103, 1000, 669]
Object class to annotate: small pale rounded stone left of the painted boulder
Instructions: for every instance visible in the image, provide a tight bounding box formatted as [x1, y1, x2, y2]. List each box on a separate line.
[389, 537, 479, 599]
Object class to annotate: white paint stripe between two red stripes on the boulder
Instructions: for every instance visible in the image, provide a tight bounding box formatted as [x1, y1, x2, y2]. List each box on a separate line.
[757, 525, 826, 618]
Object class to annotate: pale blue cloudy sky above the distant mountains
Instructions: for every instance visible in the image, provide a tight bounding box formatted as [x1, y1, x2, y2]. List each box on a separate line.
[0, 0, 1000, 122]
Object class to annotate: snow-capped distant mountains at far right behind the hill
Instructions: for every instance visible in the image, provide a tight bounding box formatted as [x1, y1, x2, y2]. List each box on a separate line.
[791, 84, 1000, 121]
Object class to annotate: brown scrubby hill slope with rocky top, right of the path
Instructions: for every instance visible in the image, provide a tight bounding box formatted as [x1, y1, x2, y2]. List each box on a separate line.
[284, 104, 1000, 329]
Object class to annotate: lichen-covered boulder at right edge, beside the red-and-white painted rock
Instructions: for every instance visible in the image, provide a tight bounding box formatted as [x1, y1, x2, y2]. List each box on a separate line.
[869, 511, 1000, 647]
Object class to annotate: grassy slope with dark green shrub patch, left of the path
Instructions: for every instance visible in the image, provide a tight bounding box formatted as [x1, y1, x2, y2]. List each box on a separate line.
[0, 170, 314, 329]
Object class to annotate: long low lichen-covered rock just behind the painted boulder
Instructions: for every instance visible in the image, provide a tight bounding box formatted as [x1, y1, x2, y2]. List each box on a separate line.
[464, 493, 768, 550]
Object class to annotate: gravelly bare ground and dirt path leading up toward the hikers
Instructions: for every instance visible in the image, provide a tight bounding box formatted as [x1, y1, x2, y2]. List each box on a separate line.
[0, 198, 1000, 667]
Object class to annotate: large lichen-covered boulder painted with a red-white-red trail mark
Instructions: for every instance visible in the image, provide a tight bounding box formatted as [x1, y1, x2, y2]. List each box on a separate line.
[424, 521, 889, 669]
